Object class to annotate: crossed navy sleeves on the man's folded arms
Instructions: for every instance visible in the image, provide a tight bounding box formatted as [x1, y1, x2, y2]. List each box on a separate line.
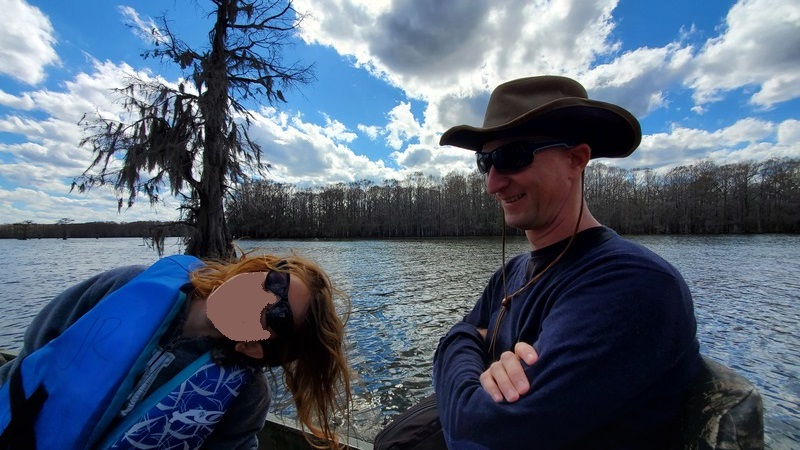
[434, 264, 696, 449]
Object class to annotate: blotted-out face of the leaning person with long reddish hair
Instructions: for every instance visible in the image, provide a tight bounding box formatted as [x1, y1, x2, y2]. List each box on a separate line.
[206, 272, 311, 342]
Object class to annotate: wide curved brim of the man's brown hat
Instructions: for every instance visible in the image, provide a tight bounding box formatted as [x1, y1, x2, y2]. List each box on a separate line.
[439, 97, 642, 158]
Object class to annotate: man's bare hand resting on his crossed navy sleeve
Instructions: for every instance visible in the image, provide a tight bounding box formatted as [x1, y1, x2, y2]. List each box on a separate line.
[481, 342, 539, 403]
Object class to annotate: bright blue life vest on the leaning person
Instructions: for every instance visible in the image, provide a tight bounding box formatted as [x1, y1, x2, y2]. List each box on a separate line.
[0, 256, 250, 449]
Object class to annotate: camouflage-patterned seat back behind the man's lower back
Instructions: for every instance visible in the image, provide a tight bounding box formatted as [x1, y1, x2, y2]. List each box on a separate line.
[675, 356, 764, 450]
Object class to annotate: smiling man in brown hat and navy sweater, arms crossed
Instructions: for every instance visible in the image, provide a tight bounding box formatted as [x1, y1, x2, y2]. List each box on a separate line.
[433, 76, 701, 449]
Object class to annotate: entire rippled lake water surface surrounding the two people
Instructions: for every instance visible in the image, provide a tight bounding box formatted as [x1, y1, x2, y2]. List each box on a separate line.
[0, 235, 800, 449]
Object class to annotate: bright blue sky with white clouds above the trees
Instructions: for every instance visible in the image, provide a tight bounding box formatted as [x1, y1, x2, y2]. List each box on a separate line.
[0, 0, 800, 224]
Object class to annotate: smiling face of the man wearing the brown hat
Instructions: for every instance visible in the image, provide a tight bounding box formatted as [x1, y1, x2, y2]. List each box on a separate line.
[481, 137, 580, 233]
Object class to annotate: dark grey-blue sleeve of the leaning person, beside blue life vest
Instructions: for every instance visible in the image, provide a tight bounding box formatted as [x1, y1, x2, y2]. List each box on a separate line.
[0, 266, 145, 385]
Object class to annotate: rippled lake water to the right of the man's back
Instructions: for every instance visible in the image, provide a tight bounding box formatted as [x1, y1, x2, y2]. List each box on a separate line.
[636, 235, 800, 449]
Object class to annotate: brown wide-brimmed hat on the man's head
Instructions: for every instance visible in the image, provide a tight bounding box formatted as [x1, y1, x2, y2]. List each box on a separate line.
[439, 76, 642, 158]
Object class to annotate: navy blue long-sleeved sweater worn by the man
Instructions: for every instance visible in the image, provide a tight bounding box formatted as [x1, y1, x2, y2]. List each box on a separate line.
[434, 227, 700, 449]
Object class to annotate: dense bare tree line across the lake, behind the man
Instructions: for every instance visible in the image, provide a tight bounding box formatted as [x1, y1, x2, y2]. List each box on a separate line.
[227, 158, 800, 239]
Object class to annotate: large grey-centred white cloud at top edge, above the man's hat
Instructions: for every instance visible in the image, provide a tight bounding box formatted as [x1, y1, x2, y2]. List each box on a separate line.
[295, 0, 618, 102]
